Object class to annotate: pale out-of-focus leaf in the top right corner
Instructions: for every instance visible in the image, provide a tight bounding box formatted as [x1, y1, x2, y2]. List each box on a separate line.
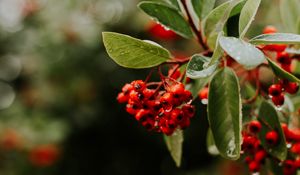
[279, 0, 300, 33]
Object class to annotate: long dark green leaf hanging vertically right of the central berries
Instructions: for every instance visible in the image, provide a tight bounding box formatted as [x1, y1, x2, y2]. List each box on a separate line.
[207, 68, 242, 160]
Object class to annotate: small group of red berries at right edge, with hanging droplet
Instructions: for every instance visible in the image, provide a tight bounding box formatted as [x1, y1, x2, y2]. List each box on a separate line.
[269, 80, 299, 106]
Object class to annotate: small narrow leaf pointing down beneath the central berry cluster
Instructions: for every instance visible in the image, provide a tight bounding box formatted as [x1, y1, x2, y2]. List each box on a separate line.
[164, 129, 183, 167]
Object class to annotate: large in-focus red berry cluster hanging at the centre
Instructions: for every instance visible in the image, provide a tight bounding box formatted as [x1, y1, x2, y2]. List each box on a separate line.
[117, 78, 195, 135]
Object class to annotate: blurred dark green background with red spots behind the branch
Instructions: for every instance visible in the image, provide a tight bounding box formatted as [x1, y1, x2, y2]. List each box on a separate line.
[0, 0, 288, 175]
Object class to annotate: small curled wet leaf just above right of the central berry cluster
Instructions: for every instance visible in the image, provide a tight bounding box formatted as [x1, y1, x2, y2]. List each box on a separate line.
[186, 54, 218, 79]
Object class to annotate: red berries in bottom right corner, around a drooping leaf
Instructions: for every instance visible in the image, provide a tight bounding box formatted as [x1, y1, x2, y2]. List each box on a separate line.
[242, 121, 300, 175]
